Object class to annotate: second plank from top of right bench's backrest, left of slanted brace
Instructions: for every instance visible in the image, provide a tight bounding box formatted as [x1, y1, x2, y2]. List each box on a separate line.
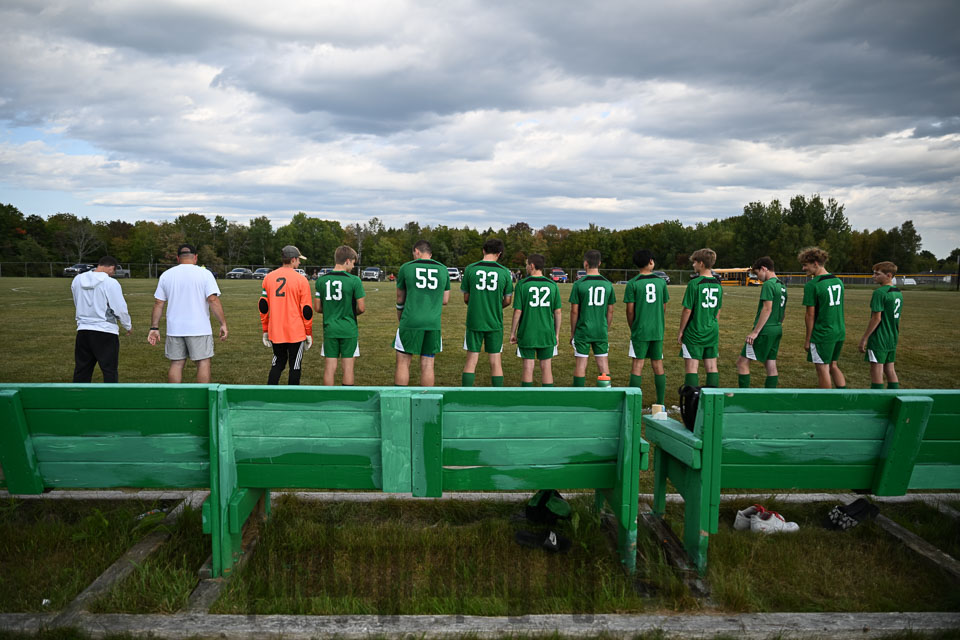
[723, 412, 889, 440]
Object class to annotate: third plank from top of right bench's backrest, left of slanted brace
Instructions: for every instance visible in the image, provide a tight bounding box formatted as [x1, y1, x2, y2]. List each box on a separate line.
[723, 439, 883, 466]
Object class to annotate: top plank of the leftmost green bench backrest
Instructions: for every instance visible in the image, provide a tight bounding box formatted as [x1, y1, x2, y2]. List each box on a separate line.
[0, 384, 211, 409]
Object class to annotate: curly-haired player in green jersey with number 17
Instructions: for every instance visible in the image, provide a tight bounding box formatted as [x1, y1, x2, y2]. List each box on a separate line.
[797, 247, 847, 389]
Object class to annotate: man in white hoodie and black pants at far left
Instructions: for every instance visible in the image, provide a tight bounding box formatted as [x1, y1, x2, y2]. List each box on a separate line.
[70, 256, 133, 382]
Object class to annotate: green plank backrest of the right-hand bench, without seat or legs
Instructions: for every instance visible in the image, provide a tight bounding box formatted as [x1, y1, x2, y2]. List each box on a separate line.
[694, 389, 960, 495]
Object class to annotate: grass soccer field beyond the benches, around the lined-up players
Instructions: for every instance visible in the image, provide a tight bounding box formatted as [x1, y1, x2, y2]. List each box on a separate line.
[0, 278, 960, 390]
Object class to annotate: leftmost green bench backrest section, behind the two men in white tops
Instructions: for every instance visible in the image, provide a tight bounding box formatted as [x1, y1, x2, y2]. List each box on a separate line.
[0, 384, 216, 494]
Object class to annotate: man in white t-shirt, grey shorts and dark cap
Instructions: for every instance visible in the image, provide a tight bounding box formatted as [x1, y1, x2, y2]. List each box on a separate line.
[147, 244, 227, 383]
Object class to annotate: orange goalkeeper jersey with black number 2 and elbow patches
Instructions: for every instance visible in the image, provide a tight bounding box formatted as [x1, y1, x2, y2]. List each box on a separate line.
[259, 267, 313, 343]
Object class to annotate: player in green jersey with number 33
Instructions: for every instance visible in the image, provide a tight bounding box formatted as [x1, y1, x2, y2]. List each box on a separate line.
[460, 238, 513, 387]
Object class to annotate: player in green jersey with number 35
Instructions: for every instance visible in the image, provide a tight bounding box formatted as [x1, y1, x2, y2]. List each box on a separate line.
[677, 249, 723, 387]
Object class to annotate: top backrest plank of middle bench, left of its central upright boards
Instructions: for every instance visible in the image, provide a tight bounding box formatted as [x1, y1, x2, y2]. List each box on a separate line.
[223, 385, 380, 413]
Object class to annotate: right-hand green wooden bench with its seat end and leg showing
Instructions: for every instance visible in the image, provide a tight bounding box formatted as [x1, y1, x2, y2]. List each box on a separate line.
[643, 389, 960, 573]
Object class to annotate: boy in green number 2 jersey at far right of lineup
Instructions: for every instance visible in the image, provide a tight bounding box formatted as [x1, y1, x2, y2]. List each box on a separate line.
[860, 262, 903, 389]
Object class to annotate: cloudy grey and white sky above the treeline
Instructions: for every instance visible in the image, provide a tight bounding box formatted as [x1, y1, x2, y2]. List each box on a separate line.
[0, 0, 960, 257]
